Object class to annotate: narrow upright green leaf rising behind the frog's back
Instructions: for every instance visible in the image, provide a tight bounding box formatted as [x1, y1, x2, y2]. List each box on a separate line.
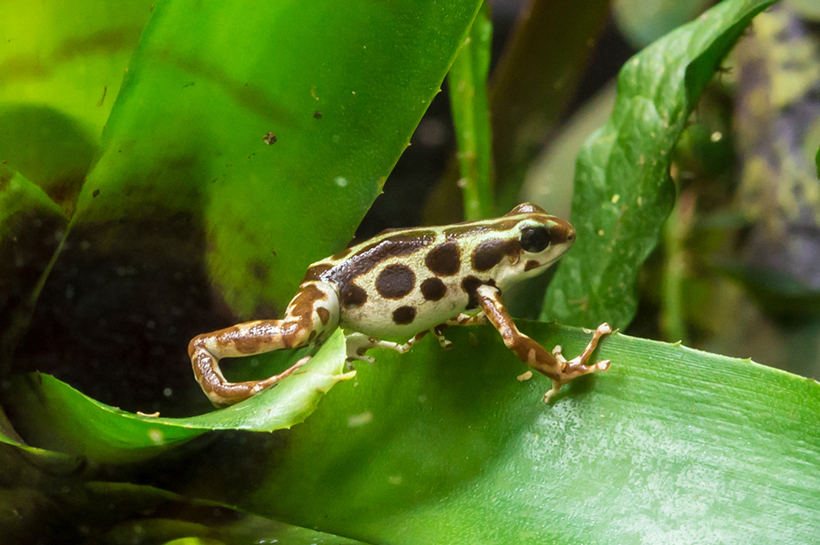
[447, 2, 493, 220]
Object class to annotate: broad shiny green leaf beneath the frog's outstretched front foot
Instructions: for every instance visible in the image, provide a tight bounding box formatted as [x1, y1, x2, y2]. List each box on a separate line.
[213, 322, 820, 544]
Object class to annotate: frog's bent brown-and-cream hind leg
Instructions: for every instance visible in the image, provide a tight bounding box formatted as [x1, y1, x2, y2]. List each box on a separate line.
[188, 282, 339, 407]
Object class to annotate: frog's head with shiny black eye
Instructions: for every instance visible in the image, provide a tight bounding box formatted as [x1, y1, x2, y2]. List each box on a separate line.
[486, 203, 575, 289]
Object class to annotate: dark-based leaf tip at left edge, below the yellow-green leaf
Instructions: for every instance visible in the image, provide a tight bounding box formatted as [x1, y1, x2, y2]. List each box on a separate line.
[0, 164, 68, 370]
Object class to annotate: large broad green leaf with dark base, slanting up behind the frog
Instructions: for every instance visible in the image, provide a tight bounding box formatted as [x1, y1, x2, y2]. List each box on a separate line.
[73, 0, 480, 317]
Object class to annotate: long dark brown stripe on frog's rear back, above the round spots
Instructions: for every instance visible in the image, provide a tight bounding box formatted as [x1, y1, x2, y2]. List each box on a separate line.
[323, 230, 436, 307]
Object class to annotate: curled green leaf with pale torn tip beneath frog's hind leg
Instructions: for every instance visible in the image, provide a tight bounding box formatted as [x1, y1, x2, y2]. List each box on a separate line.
[4, 330, 351, 464]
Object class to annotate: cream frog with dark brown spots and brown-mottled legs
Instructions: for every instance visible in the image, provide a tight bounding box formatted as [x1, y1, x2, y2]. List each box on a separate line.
[188, 203, 613, 407]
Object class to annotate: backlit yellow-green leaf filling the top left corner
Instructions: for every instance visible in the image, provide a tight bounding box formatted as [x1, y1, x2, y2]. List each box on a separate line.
[0, 0, 152, 213]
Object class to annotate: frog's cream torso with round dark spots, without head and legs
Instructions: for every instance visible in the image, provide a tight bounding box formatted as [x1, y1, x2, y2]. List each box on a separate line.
[298, 218, 536, 338]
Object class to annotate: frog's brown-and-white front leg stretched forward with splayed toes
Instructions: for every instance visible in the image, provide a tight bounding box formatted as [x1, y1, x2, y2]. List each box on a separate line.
[476, 285, 612, 402]
